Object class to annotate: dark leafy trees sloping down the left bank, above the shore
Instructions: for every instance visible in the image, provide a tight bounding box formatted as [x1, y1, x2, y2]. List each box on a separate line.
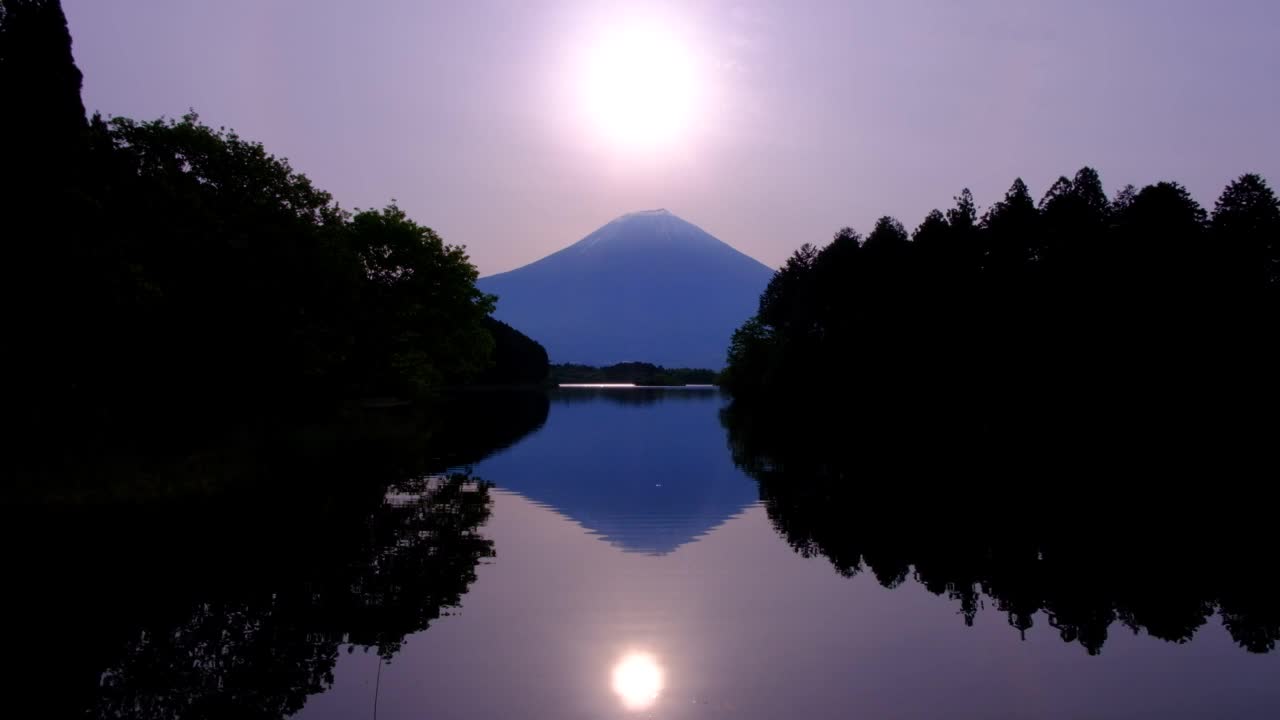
[0, 0, 547, 430]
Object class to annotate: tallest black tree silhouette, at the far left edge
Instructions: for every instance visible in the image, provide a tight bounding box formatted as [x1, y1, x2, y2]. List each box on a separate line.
[0, 0, 97, 420]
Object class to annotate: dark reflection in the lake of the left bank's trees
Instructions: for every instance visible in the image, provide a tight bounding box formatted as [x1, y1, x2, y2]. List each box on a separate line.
[10, 392, 548, 717]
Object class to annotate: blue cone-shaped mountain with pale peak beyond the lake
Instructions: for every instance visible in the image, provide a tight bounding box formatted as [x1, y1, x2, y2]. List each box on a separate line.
[477, 210, 773, 369]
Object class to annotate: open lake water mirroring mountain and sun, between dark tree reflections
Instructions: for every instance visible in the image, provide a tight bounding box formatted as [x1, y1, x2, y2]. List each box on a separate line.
[290, 391, 1280, 719]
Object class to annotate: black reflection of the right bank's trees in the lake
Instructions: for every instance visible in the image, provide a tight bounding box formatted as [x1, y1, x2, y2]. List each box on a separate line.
[722, 405, 1280, 653]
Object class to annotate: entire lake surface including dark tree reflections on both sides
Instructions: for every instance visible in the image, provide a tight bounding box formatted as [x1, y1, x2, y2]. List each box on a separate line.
[6, 389, 1280, 720]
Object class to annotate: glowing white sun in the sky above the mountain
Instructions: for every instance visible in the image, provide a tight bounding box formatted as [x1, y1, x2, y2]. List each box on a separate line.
[582, 19, 698, 150]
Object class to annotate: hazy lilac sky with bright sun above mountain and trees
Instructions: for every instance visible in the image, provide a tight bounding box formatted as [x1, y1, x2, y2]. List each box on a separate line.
[63, 0, 1280, 274]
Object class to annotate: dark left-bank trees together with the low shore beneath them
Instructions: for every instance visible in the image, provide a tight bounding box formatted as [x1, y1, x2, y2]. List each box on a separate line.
[0, 0, 558, 505]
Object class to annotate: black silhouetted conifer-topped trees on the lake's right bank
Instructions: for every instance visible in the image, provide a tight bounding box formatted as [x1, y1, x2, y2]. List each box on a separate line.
[722, 168, 1280, 445]
